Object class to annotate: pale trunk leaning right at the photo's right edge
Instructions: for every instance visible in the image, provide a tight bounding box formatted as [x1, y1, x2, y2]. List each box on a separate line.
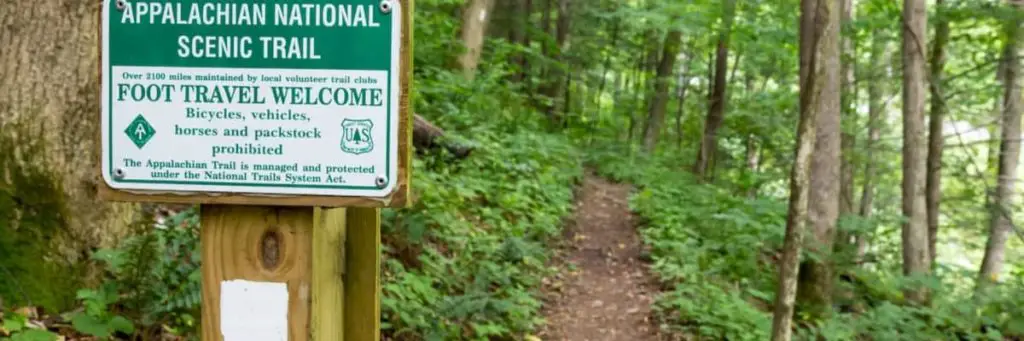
[978, 4, 1024, 287]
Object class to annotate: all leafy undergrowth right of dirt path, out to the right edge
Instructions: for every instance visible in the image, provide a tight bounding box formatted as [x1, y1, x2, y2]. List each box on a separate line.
[588, 144, 1024, 340]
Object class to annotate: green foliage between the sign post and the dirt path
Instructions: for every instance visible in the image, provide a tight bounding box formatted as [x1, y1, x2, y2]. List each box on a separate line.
[382, 70, 582, 340]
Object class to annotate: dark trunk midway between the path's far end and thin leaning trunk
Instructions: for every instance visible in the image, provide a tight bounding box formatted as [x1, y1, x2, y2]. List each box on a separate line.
[693, 0, 736, 179]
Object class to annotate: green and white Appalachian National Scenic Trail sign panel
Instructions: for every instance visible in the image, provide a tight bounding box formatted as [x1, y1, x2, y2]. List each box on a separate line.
[101, 0, 401, 197]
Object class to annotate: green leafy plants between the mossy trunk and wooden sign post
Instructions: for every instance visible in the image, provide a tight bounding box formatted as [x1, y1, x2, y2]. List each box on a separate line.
[69, 209, 202, 338]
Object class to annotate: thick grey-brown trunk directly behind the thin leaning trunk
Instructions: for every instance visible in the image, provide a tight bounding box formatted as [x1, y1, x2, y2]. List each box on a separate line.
[797, 0, 843, 321]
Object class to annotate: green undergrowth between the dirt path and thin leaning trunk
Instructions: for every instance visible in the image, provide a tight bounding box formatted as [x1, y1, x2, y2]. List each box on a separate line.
[590, 145, 785, 340]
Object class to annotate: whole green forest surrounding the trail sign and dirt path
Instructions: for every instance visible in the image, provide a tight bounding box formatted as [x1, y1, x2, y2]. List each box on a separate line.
[0, 0, 1024, 340]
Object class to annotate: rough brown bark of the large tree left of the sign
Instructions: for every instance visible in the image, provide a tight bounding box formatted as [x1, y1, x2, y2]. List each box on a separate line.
[0, 0, 140, 268]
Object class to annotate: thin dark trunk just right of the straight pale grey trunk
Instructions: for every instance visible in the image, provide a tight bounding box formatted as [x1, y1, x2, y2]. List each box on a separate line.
[925, 0, 949, 265]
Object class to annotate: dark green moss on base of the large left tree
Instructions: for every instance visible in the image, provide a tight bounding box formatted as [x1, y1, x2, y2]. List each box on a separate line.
[0, 125, 84, 310]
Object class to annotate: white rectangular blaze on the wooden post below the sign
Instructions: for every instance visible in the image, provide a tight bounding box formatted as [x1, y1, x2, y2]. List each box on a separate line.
[220, 280, 288, 341]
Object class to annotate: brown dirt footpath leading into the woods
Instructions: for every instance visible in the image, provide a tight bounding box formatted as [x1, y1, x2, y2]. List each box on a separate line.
[540, 172, 657, 341]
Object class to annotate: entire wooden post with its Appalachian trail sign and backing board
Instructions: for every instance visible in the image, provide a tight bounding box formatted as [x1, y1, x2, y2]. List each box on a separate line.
[98, 0, 413, 341]
